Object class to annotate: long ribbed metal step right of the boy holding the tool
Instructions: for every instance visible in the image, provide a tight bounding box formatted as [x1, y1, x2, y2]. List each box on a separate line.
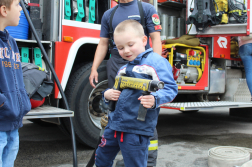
[160, 101, 252, 111]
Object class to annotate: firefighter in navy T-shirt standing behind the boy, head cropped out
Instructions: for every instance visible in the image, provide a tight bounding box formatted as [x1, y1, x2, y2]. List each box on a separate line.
[89, 0, 162, 167]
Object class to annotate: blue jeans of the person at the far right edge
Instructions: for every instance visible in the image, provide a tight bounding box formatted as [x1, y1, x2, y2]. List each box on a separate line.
[239, 43, 252, 93]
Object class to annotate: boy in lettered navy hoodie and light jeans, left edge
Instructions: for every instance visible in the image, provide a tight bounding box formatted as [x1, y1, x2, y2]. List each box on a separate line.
[0, 0, 31, 167]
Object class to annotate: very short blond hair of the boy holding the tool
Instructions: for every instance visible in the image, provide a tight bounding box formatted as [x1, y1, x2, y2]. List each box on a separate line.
[114, 19, 145, 37]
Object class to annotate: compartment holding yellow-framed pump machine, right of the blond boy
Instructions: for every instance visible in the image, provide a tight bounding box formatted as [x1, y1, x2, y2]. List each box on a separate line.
[163, 43, 208, 90]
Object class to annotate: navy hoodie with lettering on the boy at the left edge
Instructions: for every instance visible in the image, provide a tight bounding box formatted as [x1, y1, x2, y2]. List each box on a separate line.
[0, 30, 31, 131]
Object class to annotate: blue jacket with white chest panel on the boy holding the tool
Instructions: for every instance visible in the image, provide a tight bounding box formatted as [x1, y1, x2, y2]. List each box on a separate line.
[107, 48, 178, 136]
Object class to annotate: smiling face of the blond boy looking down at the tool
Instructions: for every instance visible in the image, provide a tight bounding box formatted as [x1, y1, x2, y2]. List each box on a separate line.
[114, 28, 147, 61]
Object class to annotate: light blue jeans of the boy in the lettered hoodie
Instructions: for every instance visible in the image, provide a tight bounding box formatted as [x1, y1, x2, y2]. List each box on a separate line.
[0, 129, 19, 167]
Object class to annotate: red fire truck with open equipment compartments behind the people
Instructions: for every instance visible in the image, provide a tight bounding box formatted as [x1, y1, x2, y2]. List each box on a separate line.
[19, 0, 251, 147]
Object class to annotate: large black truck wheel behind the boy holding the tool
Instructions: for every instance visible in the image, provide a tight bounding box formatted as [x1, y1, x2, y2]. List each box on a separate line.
[63, 61, 108, 147]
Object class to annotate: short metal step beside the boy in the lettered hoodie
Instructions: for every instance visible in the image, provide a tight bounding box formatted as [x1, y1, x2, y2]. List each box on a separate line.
[24, 105, 74, 119]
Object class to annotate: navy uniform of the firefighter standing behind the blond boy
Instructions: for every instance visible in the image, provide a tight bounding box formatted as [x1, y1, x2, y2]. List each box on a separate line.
[100, 0, 161, 166]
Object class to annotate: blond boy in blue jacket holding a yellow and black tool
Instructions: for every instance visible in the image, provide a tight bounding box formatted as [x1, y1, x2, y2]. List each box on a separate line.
[95, 20, 178, 167]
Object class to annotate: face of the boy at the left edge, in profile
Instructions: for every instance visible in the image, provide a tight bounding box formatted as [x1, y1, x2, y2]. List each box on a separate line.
[7, 0, 22, 26]
